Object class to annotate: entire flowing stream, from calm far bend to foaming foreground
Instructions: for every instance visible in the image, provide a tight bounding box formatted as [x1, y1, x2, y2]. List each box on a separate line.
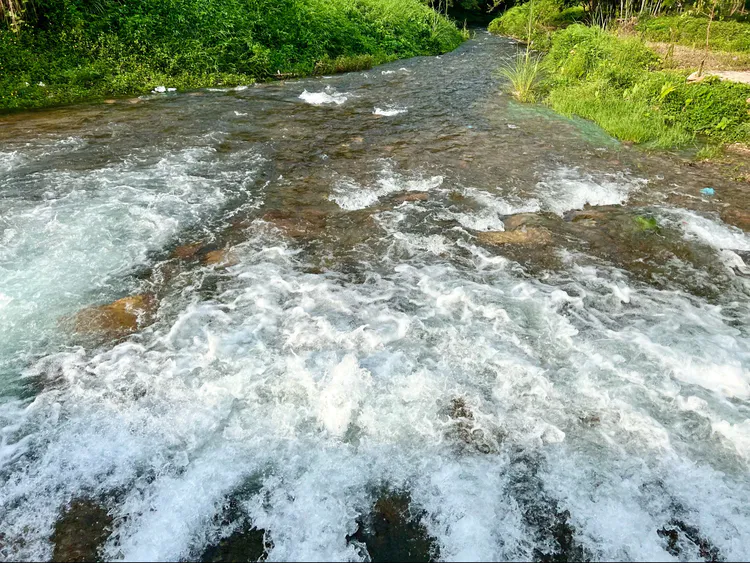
[0, 34, 750, 560]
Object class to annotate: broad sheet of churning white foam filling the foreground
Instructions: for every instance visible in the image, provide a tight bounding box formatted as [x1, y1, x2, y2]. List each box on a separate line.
[0, 230, 750, 560]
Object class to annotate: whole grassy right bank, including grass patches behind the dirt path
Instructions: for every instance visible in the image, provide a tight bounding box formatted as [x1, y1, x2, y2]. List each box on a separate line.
[491, 0, 750, 152]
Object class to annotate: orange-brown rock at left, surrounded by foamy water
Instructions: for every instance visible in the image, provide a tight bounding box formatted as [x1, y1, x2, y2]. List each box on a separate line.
[75, 293, 158, 339]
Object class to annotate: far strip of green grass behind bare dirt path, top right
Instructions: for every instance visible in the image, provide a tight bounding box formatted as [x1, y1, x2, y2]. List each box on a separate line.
[636, 14, 750, 52]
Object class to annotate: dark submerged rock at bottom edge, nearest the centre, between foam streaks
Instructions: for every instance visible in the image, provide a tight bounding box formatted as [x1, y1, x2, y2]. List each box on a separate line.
[347, 491, 440, 563]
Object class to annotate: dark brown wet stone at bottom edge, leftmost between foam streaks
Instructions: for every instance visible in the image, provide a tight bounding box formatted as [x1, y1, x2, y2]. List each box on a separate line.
[51, 500, 112, 561]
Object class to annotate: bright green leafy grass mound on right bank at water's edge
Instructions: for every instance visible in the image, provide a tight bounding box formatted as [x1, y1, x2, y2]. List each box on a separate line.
[541, 25, 750, 148]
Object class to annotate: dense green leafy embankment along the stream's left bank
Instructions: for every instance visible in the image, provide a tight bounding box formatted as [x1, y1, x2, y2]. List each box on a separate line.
[0, 0, 462, 110]
